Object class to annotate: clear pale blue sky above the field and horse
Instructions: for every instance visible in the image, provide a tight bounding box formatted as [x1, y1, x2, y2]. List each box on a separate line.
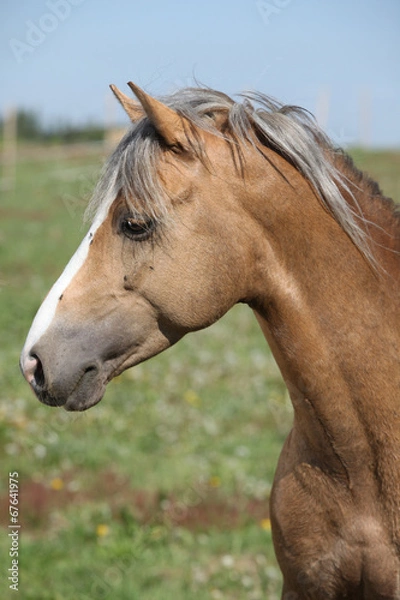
[0, 0, 400, 147]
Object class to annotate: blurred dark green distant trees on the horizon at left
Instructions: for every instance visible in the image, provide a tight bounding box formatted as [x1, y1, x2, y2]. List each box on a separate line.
[0, 109, 105, 144]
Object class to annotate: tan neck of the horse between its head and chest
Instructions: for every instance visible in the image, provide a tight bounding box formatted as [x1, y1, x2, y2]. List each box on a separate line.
[247, 151, 400, 496]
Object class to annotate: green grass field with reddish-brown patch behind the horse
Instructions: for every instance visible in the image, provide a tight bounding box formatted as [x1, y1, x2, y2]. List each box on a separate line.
[0, 143, 400, 600]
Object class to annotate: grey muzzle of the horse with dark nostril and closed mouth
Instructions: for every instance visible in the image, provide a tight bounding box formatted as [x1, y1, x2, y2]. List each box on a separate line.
[20, 303, 179, 411]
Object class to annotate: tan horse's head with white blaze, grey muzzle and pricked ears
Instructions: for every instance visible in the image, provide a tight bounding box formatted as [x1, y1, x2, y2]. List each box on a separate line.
[21, 84, 262, 410]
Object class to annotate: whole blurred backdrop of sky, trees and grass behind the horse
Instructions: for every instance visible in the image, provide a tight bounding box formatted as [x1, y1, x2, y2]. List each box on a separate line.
[0, 0, 400, 600]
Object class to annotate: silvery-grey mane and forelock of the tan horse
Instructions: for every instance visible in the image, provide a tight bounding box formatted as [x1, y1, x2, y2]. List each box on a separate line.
[89, 88, 388, 263]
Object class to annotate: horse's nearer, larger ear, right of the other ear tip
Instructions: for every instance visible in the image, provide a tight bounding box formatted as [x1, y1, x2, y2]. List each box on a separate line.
[128, 81, 189, 148]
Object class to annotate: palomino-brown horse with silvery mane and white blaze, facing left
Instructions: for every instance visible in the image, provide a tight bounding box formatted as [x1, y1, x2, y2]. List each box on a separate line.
[20, 82, 400, 600]
